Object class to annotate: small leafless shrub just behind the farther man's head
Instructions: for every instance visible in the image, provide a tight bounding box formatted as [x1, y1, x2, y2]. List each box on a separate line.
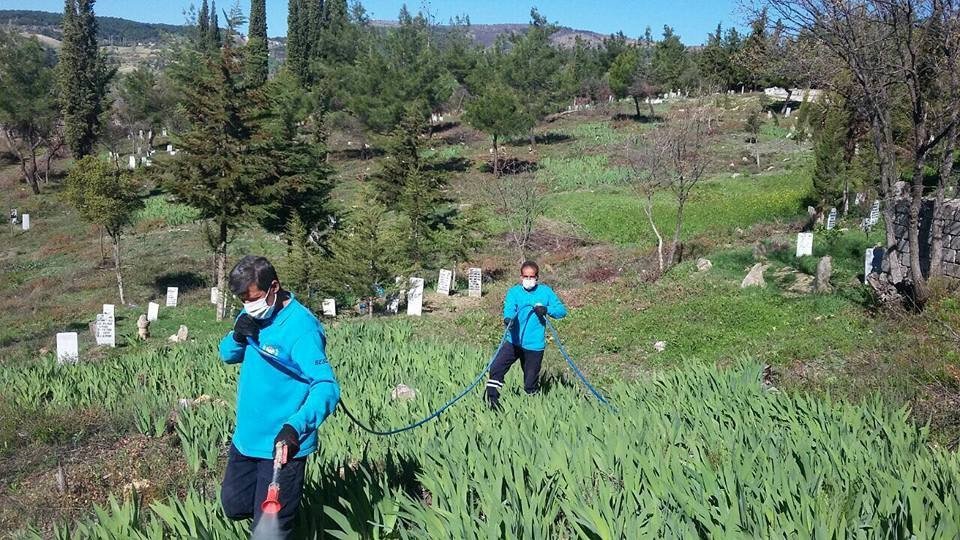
[488, 173, 546, 260]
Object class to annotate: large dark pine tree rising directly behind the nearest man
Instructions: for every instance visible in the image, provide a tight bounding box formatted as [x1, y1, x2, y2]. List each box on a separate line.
[164, 21, 326, 318]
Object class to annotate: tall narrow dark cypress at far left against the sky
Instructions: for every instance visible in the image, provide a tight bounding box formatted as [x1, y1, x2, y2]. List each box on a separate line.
[58, 0, 116, 159]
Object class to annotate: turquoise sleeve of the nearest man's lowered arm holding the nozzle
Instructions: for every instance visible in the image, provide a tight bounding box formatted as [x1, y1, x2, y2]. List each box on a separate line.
[287, 328, 340, 437]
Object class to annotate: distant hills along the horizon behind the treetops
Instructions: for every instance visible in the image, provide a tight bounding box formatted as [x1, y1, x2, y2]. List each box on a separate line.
[0, 10, 632, 47]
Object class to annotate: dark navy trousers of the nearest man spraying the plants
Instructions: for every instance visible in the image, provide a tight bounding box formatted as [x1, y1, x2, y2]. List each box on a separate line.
[220, 444, 307, 538]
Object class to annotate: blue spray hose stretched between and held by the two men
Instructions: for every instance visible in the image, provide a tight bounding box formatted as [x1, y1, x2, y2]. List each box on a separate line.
[247, 317, 618, 436]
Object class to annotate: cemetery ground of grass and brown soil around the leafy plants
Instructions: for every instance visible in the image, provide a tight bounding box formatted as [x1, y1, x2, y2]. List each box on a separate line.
[0, 96, 960, 532]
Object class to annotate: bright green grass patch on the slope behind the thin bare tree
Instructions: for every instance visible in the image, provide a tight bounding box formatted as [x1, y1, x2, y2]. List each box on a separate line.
[547, 171, 811, 246]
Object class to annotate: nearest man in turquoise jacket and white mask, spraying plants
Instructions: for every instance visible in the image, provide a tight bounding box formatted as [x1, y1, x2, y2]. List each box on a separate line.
[220, 255, 340, 537]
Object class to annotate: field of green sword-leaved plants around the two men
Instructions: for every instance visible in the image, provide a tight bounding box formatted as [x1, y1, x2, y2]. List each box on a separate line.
[7, 322, 960, 539]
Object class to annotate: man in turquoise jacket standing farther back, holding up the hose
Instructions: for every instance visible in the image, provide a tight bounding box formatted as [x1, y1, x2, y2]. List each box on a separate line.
[487, 261, 567, 408]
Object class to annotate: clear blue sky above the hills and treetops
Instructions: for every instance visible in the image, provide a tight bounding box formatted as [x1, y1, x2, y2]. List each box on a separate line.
[0, 0, 743, 44]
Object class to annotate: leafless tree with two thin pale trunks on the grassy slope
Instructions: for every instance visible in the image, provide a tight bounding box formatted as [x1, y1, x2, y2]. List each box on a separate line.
[628, 104, 711, 272]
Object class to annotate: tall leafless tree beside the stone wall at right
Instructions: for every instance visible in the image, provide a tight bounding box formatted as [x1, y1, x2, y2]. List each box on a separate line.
[754, 0, 960, 305]
